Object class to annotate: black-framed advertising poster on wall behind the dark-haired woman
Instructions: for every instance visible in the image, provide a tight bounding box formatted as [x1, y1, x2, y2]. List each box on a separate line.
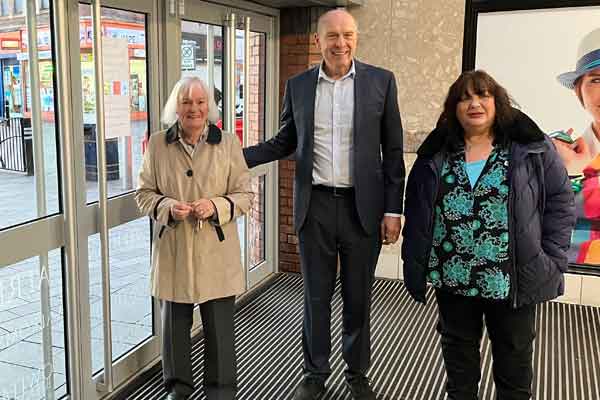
[464, 2, 600, 268]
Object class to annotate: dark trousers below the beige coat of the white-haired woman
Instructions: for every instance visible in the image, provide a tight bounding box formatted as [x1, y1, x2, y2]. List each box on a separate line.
[161, 296, 237, 395]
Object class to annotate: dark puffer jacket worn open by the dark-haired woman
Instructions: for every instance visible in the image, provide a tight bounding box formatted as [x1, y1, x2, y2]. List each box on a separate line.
[402, 112, 575, 307]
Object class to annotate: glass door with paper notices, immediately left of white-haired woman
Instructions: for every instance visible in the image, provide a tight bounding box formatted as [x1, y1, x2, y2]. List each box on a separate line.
[65, 0, 160, 399]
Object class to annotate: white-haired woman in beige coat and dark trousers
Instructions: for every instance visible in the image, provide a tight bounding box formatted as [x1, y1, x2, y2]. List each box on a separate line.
[136, 77, 253, 400]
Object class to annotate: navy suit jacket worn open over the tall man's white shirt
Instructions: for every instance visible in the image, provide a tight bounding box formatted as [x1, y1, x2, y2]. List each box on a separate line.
[244, 60, 405, 234]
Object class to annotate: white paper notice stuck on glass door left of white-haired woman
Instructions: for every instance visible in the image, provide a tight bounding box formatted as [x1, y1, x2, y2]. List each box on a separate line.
[102, 36, 131, 139]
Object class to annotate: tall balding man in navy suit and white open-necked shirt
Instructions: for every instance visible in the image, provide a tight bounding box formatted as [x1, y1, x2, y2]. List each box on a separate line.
[244, 9, 405, 400]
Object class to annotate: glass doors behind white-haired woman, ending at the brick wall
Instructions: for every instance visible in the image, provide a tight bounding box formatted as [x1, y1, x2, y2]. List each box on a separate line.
[164, 1, 278, 290]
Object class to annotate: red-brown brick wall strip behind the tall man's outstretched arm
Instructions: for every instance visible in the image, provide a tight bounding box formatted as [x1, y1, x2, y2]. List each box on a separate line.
[279, 7, 327, 272]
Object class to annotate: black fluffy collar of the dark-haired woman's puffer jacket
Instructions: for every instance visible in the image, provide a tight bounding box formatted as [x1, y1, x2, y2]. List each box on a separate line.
[417, 110, 545, 158]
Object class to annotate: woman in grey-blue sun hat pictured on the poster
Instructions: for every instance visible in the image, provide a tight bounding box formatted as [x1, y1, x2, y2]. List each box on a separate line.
[551, 28, 600, 264]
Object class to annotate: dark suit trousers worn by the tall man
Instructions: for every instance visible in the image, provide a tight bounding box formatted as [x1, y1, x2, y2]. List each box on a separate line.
[298, 188, 381, 380]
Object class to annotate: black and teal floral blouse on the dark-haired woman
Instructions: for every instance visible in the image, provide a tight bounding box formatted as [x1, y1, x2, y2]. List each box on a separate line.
[427, 148, 510, 300]
